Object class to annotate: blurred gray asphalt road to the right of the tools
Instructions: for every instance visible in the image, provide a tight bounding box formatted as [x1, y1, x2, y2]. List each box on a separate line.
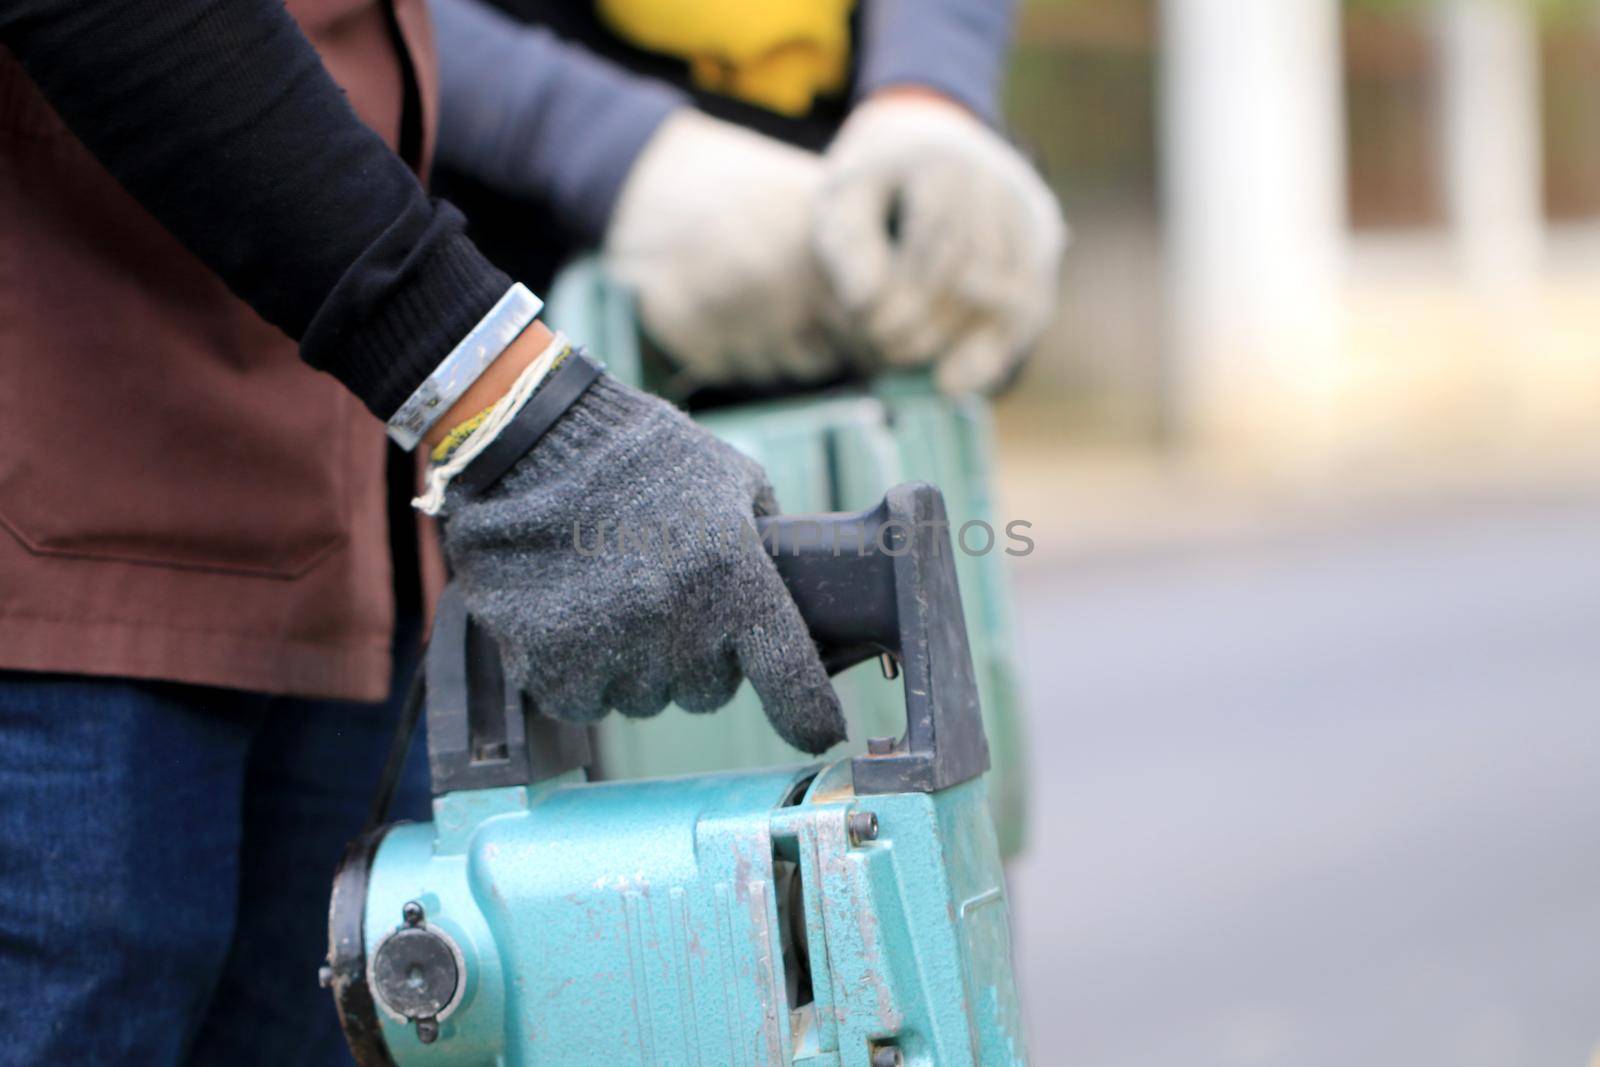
[1013, 494, 1600, 1067]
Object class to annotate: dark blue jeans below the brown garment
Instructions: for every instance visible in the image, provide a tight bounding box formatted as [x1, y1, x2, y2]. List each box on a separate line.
[0, 630, 427, 1067]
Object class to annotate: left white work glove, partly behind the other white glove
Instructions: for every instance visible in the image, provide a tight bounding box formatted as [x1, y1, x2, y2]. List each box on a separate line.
[603, 109, 840, 384]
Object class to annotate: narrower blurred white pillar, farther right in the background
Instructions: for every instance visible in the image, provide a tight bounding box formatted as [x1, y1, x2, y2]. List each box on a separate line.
[1435, 0, 1544, 296]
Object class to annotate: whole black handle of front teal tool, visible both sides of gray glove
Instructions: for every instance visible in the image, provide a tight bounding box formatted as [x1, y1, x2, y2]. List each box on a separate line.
[426, 485, 989, 795]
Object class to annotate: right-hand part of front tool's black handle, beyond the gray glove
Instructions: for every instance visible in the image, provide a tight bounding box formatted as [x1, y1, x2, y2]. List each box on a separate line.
[757, 483, 989, 793]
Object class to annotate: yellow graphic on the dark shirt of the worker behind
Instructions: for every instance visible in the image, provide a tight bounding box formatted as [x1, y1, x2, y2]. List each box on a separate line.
[595, 0, 854, 115]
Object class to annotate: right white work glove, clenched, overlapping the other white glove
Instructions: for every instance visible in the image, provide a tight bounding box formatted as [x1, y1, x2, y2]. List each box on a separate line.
[813, 94, 1067, 394]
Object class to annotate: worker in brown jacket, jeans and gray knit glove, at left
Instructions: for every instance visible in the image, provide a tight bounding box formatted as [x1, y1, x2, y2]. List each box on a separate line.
[0, 0, 843, 1067]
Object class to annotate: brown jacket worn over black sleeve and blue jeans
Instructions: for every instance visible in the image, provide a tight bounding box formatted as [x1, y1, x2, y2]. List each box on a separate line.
[0, 0, 435, 699]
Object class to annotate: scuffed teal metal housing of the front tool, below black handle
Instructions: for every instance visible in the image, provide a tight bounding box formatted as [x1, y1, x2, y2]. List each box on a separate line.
[363, 760, 1026, 1067]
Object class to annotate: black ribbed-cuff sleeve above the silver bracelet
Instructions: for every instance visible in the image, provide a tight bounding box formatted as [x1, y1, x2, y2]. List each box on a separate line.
[0, 0, 510, 419]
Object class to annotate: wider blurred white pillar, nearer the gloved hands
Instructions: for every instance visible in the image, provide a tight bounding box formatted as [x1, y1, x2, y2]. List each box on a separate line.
[1162, 0, 1346, 442]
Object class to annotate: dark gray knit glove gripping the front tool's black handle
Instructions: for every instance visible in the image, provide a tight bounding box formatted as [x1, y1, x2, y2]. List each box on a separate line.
[432, 374, 845, 752]
